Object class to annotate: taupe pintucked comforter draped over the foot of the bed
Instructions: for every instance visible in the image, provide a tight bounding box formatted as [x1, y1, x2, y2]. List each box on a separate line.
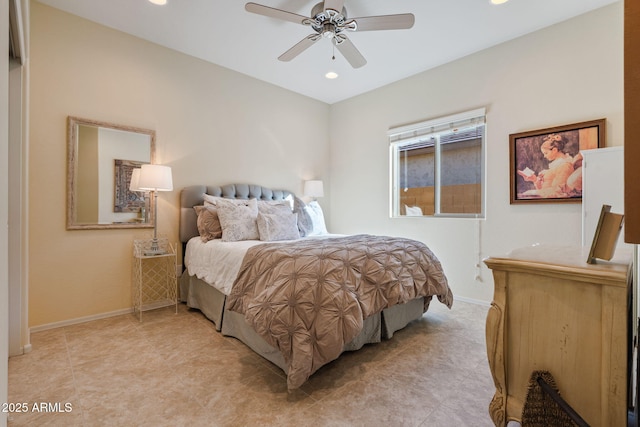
[227, 235, 453, 390]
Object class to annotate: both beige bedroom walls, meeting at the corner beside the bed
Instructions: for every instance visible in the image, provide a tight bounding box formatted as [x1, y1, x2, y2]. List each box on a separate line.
[29, 2, 623, 327]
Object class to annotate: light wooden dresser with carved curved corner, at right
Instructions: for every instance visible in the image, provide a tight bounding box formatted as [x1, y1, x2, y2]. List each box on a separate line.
[484, 245, 632, 427]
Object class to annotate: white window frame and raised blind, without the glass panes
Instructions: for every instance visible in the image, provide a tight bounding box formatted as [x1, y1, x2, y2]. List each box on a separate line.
[387, 108, 487, 219]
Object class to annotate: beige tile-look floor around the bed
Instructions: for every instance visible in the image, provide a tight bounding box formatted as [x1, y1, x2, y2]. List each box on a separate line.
[9, 301, 494, 427]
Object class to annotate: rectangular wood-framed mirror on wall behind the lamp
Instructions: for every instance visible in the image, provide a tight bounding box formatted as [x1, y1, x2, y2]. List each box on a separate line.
[67, 116, 156, 230]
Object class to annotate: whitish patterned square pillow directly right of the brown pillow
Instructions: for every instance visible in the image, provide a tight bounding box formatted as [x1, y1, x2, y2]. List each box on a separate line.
[216, 199, 260, 242]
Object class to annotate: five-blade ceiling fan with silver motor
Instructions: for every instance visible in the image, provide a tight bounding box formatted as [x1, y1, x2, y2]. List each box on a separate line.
[245, 0, 415, 68]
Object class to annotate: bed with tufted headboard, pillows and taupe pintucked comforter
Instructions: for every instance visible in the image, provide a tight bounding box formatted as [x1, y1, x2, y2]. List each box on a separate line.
[179, 184, 453, 390]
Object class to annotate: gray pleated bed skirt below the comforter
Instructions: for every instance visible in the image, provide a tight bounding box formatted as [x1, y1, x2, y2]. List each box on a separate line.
[180, 271, 424, 373]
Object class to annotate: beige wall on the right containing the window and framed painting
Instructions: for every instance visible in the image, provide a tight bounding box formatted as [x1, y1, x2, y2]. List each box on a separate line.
[330, 2, 623, 301]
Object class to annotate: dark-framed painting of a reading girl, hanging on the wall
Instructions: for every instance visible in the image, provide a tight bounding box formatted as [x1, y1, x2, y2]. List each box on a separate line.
[509, 119, 606, 204]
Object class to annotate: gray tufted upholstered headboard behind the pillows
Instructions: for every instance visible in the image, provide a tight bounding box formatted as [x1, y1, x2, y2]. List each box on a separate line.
[180, 184, 292, 246]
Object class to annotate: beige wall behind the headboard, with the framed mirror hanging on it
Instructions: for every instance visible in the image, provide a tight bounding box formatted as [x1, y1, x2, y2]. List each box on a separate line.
[29, 1, 329, 327]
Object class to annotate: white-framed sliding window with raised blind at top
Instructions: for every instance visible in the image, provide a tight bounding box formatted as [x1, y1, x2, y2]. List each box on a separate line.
[389, 108, 485, 218]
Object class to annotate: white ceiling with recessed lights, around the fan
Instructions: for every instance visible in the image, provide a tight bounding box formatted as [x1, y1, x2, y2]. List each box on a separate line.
[39, 0, 618, 104]
